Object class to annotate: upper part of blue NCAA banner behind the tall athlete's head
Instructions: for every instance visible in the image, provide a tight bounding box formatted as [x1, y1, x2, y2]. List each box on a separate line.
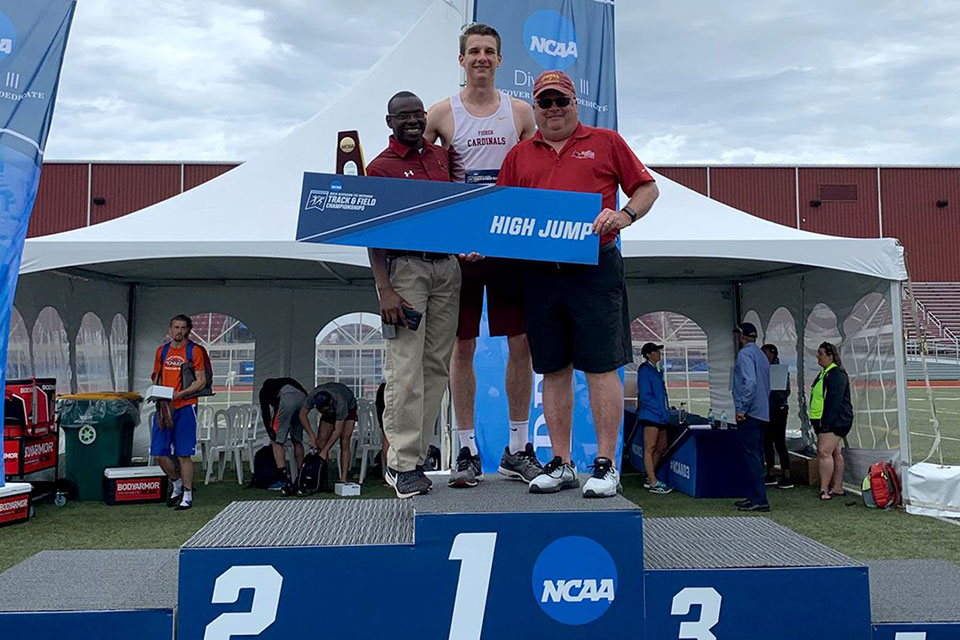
[474, 0, 617, 129]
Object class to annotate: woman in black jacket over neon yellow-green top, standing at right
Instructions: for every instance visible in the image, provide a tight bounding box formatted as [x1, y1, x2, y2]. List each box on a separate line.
[810, 342, 853, 500]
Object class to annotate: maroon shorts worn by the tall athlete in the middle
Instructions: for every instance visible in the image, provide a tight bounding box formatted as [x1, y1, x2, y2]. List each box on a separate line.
[457, 258, 527, 339]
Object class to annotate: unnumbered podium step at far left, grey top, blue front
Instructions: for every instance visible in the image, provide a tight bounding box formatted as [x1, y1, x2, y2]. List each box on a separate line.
[0, 550, 177, 640]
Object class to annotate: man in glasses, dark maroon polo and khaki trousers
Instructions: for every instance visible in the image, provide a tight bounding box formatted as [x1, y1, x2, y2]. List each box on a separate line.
[367, 91, 460, 498]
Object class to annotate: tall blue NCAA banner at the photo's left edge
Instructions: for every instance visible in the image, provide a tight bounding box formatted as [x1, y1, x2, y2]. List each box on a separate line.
[0, 0, 76, 486]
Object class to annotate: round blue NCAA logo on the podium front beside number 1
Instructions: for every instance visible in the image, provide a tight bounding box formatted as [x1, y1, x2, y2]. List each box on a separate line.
[532, 536, 617, 625]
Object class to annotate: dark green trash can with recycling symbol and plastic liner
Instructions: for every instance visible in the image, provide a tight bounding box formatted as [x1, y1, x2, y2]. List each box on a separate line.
[57, 392, 142, 500]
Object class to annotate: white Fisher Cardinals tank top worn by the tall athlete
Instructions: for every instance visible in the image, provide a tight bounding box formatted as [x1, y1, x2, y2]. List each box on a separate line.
[450, 91, 520, 184]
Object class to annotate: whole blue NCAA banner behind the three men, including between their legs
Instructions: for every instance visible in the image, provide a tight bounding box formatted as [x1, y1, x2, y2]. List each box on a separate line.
[474, 0, 623, 473]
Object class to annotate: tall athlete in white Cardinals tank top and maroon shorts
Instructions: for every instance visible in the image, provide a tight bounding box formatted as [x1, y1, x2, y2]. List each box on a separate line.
[424, 24, 542, 487]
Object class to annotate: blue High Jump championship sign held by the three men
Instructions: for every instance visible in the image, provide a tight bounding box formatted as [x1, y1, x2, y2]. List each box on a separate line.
[296, 173, 602, 264]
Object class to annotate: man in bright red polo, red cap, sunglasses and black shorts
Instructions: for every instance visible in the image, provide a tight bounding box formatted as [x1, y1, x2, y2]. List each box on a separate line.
[497, 71, 659, 498]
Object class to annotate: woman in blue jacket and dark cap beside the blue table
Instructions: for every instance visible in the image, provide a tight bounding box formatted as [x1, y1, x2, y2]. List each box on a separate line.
[637, 342, 673, 493]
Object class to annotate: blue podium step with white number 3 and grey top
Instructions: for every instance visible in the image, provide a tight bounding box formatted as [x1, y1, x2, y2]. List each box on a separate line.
[644, 517, 871, 640]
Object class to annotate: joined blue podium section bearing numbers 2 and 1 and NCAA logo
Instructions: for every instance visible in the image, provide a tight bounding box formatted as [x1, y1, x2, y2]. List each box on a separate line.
[178, 477, 644, 640]
